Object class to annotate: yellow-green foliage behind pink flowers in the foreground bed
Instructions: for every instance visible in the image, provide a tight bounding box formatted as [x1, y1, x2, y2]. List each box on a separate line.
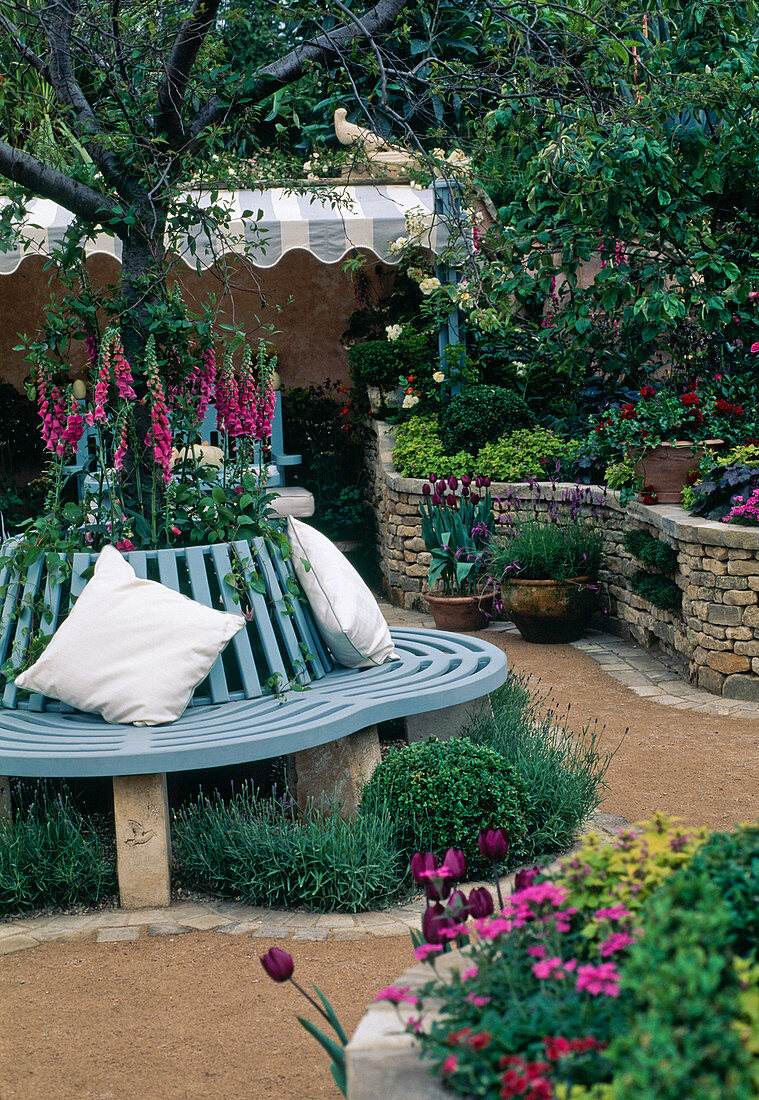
[557, 814, 706, 934]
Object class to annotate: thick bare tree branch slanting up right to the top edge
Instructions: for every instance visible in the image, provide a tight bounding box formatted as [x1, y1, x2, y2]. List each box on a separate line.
[189, 0, 409, 141]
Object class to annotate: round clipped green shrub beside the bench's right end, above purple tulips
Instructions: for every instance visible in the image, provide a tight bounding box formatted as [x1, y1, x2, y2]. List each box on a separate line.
[362, 737, 526, 867]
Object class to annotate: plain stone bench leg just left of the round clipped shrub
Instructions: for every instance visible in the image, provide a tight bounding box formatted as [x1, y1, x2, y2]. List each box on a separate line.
[289, 726, 380, 817]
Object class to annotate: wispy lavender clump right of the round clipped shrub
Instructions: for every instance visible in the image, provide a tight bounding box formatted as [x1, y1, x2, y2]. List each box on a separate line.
[464, 673, 613, 860]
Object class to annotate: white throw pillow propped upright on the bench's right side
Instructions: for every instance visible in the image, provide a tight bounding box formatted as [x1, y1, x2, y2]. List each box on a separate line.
[287, 516, 395, 669]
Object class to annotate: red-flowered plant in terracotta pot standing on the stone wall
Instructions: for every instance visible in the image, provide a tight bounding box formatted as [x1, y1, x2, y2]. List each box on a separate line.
[592, 385, 727, 504]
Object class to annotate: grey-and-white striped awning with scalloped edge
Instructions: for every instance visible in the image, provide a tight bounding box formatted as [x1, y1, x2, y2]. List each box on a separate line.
[0, 184, 449, 275]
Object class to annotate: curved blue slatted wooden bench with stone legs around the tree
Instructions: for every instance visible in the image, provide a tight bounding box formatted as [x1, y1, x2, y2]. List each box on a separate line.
[0, 539, 506, 908]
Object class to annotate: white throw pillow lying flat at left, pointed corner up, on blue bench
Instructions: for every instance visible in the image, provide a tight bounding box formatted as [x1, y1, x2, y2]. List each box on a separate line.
[15, 546, 245, 726]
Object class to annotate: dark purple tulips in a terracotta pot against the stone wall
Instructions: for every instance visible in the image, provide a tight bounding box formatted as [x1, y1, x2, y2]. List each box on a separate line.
[419, 474, 495, 631]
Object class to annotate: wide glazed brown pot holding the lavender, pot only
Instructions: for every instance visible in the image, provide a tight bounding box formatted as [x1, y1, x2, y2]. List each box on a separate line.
[501, 576, 597, 646]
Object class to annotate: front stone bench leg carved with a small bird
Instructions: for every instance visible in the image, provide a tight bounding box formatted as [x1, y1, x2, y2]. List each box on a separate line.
[113, 774, 172, 909]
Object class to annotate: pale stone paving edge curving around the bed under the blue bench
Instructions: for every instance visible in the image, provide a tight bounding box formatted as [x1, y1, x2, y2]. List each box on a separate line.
[0, 813, 627, 955]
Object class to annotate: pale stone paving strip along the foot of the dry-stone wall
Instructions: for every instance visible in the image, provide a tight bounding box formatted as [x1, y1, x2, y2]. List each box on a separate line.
[381, 602, 759, 718]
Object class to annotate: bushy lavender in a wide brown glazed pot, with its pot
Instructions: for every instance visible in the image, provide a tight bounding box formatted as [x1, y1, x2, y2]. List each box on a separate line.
[490, 491, 603, 645]
